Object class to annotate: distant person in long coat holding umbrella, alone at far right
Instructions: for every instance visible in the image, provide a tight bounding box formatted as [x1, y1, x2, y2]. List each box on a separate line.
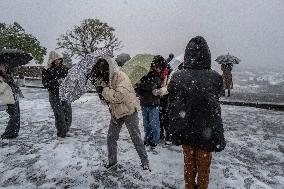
[215, 53, 241, 97]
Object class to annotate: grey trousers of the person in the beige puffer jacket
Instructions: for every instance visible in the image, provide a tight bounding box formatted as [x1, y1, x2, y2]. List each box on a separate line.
[107, 112, 149, 165]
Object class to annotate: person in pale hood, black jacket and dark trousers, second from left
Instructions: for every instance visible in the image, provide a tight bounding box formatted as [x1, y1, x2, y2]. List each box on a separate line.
[42, 51, 72, 138]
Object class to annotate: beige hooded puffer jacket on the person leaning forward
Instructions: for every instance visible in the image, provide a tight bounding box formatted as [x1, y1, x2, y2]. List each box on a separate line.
[102, 71, 140, 119]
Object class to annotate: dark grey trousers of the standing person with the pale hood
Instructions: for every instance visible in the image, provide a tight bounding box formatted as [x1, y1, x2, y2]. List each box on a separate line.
[49, 92, 72, 137]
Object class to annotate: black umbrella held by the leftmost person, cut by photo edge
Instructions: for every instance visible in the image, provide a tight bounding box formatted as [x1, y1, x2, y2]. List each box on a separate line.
[0, 49, 33, 69]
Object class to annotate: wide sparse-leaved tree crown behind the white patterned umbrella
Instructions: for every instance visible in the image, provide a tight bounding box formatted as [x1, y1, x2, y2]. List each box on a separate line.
[57, 19, 121, 58]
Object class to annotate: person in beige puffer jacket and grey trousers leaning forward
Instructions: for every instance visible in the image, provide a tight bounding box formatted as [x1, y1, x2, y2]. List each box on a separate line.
[89, 59, 150, 170]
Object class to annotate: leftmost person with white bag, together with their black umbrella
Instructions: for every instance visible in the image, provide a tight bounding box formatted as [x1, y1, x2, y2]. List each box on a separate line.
[0, 49, 33, 139]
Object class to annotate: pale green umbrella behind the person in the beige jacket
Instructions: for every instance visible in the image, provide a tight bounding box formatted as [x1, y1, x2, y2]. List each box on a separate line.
[122, 54, 154, 85]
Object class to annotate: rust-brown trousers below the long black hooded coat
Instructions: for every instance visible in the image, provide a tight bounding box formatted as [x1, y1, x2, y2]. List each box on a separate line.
[182, 144, 212, 189]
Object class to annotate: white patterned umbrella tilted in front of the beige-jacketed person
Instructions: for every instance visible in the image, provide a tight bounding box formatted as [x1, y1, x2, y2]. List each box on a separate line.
[59, 49, 112, 102]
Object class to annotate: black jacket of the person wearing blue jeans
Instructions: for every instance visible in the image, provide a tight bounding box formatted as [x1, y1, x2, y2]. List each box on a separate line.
[135, 71, 162, 106]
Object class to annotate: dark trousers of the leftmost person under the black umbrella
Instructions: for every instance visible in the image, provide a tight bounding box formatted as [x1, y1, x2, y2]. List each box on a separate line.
[3, 101, 20, 136]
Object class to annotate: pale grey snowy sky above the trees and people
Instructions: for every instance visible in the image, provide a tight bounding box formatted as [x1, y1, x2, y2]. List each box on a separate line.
[0, 0, 284, 68]
